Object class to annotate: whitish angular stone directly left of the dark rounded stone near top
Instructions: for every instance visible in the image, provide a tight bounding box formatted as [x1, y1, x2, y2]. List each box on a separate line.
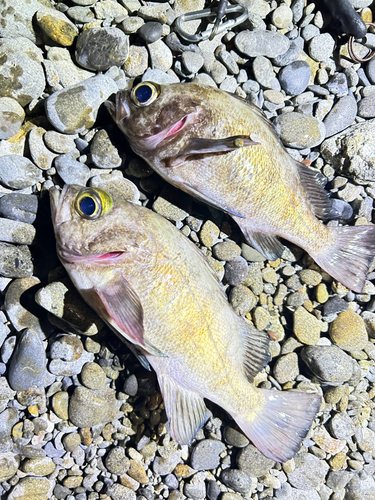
[44, 47, 94, 87]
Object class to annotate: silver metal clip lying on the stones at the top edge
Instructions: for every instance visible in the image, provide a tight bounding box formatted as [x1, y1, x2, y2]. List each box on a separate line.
[175, 0, 248, 43]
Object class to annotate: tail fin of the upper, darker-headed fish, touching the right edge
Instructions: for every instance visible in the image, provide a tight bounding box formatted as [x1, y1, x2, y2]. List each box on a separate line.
[311, 225, 375, 293]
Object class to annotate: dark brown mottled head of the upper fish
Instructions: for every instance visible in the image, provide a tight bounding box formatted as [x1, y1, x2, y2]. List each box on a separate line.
[107, 82, 210, 164]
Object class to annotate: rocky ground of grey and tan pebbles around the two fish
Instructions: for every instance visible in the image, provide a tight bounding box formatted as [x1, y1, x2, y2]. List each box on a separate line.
[0, 0, 375, 500]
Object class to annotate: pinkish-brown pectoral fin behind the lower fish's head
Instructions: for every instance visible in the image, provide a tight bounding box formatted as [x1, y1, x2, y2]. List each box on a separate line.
[81, 274, 163, 356]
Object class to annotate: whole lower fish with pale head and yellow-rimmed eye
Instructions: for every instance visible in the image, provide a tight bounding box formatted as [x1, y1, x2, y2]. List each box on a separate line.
[50, 185, 321, 462]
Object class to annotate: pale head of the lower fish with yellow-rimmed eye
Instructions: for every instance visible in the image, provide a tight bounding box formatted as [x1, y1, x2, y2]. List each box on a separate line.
[50, 185, 152, 265]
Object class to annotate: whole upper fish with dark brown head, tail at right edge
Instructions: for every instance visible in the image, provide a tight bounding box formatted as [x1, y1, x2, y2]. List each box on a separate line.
[107, 82, 375, 292]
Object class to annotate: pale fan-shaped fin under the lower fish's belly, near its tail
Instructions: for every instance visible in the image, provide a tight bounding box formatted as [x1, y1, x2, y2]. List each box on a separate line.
[158, 375, 210, 445]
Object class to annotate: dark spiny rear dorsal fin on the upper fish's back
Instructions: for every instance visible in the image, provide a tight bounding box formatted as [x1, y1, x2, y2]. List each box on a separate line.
[295, 161, 335, 218]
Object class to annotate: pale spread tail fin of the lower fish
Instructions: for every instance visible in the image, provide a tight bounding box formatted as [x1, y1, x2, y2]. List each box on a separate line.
[233, 389, 321, 462]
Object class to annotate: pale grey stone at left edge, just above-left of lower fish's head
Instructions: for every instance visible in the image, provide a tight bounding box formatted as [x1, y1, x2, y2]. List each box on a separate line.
[0, 155, 43, 189]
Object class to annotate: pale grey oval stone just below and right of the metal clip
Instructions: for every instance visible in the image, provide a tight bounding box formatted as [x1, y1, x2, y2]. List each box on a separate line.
[234, 30, 290, 58]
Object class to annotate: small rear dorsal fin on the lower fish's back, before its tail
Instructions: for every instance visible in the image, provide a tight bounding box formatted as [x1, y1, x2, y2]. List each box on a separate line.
[242, 324, 271, 382]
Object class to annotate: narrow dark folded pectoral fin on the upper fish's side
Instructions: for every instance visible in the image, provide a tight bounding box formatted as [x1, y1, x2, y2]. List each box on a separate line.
[170, 135, 260, 167]
